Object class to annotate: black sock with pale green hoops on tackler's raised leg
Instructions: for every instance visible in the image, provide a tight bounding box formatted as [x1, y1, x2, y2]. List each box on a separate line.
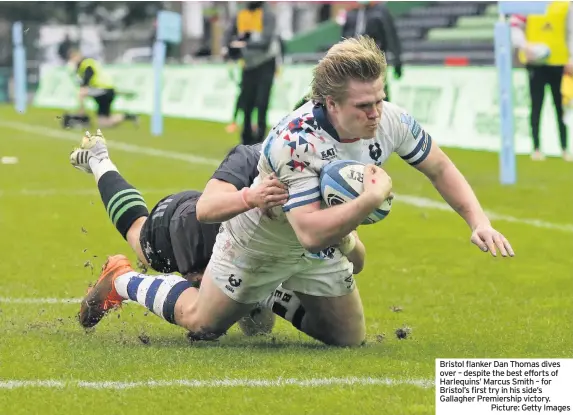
[97, 171, 149, 239]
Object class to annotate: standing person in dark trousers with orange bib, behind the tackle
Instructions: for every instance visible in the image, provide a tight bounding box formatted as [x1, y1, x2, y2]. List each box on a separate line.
[222, 1, 280, 145]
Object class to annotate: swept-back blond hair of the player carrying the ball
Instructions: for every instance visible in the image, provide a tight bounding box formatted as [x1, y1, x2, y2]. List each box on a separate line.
[310, 36, 386, 104]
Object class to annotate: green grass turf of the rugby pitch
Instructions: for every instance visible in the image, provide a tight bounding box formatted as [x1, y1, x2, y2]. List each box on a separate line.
[0, 107, 573, 415]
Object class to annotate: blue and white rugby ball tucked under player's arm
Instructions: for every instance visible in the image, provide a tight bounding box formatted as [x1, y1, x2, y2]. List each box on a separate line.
[320, 160, 392, 225]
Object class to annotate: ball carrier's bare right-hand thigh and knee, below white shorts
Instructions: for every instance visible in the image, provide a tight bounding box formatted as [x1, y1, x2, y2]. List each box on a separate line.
[295, 287, 366, 346]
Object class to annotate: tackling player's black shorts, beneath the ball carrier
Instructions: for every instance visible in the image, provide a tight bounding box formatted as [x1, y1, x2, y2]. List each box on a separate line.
[139, 191, 220, 276]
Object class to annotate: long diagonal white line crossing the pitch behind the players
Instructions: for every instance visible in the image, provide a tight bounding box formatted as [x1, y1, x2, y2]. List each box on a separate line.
[0, 121, 573, 233]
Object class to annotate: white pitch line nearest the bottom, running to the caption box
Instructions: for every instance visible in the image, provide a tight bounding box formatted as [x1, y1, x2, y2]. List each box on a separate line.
[0, 377, 434, 390]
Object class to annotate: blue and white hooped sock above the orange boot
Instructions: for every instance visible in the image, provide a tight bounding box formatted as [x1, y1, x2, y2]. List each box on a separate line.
[114, 272, 192, 324]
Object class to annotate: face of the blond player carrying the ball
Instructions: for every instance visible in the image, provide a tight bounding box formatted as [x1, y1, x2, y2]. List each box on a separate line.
[329, 78, 385, 138]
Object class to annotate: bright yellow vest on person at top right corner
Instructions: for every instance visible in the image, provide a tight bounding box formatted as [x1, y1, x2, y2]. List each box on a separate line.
[519, 1, 569, 66]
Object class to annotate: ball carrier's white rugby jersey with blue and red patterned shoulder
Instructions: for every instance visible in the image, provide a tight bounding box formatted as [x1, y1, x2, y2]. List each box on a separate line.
[221, 102, 432, 257]
